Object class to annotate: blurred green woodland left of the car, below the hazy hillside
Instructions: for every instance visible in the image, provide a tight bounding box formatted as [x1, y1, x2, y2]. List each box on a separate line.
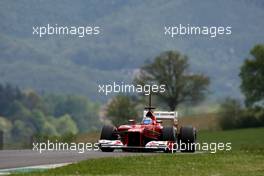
[0, 84, 100, 146]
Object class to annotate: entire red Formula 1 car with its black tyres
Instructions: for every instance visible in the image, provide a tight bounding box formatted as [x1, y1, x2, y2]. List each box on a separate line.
[99, 103, 196, 152]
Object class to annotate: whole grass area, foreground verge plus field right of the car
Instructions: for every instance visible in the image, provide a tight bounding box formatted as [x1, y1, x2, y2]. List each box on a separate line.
[12, 128, 264, 176]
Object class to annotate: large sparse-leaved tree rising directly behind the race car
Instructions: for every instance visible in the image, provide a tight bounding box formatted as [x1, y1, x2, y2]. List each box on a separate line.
[135, 51, 210, 111]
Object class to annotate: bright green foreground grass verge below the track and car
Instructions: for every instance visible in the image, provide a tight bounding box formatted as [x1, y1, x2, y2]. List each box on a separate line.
[12, 151, 264, 176]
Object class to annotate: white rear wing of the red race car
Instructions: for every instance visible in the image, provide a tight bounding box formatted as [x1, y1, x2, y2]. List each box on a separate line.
[143, 111, 178, 125]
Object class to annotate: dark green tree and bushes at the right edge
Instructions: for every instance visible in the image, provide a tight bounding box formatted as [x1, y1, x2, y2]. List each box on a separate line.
[220, 45, 264, 129]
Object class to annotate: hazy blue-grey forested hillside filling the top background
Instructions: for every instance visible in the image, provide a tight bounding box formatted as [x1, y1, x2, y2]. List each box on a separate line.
[0, 0, 264, 100]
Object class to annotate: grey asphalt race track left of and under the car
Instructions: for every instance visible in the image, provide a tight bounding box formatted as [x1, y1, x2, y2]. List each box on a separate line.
[0, 150, 153, 169]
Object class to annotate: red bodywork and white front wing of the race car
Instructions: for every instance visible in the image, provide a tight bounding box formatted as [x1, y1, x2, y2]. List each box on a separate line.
[99, 110, 175, 152]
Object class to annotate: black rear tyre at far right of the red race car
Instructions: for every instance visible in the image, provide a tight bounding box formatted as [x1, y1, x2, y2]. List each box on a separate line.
[178, 126, 196, 152]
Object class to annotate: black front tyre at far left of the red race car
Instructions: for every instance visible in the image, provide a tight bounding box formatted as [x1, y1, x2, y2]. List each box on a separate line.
[100, 125, 117, 152]
